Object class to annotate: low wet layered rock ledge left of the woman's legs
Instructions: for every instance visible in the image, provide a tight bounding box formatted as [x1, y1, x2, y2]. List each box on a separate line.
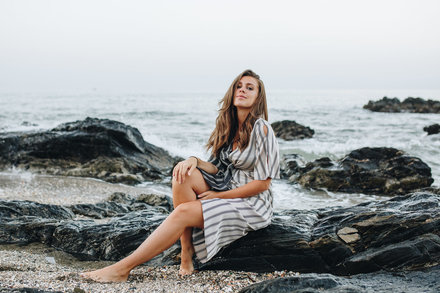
[0, 194, 174, 260]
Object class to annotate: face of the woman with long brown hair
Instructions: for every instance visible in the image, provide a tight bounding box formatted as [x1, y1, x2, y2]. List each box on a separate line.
[234, 76, 258, 109]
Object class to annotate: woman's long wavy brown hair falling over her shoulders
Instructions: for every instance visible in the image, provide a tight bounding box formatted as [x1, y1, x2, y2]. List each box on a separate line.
[206, 69, 268, 157]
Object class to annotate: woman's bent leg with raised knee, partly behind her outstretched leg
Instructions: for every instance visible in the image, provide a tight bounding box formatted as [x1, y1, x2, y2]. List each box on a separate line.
[173, 169, 209, 275]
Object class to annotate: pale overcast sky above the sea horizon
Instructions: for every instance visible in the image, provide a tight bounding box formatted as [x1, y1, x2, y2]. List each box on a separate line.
[0, 0, 440, 92]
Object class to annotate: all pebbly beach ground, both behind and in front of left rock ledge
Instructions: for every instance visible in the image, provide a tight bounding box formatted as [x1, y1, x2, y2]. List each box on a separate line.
[0, 172, 298, 292]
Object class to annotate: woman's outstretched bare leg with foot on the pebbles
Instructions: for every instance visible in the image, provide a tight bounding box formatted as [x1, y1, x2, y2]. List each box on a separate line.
[83, 201, 203, 282]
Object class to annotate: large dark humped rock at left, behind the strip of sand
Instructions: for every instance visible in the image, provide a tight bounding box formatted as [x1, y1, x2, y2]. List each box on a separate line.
[0, 118, 177, 184]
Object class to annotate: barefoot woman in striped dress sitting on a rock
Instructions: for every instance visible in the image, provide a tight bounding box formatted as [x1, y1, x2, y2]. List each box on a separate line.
[82, 70, 279, 282]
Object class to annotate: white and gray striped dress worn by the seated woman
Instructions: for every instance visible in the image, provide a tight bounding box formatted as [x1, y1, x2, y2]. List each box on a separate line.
[192, 118, 280, 263]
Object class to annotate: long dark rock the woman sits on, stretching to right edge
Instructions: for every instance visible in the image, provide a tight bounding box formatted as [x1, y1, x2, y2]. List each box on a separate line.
[199, 193, 440, 275]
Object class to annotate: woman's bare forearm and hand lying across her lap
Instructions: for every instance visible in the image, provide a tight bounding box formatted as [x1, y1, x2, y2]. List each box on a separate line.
[198, 178, 272, 199]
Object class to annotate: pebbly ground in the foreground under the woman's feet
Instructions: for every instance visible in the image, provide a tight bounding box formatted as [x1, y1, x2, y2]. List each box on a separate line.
[0, 244, 299, 292]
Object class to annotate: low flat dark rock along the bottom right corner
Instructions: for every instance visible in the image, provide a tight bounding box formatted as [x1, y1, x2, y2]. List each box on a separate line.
[240, 265, 440, 293]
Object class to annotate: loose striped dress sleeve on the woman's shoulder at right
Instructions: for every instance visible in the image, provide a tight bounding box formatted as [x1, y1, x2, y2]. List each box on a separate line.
[253, 119, 280, 180]
